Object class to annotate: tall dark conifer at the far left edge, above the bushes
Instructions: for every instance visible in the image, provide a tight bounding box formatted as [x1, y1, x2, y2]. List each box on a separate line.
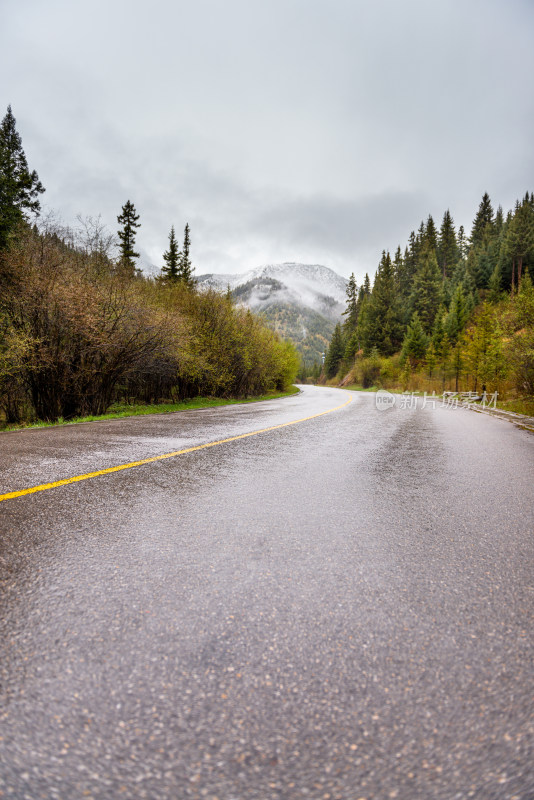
[0, 106, 44, 251]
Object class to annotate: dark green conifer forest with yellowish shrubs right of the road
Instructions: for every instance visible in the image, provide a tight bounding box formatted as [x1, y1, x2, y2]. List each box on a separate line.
[322, 193, 534, 406]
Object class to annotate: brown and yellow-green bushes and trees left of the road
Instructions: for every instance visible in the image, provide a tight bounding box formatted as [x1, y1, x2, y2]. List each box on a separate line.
[0, 108, 299, 432]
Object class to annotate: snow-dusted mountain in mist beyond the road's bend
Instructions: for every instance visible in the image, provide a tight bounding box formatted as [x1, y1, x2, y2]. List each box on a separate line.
[197, 262, 347, 366]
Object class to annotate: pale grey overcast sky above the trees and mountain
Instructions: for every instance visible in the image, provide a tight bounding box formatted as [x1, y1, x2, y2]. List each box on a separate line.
[0, 0, 534, 279]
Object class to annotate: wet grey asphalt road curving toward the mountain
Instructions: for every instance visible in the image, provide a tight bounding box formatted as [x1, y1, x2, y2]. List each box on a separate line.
[0, 387, 534, 800]
